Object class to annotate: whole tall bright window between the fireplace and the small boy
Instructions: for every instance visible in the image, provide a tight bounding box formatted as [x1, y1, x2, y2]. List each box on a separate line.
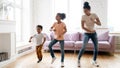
[15, 0, 31, 42]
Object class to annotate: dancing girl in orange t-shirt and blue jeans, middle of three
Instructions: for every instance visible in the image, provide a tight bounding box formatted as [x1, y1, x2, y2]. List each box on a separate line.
[49, 13, 67, 67]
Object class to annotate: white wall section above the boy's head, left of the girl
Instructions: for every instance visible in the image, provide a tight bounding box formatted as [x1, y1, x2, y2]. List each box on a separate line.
[33, 0, 52, 33]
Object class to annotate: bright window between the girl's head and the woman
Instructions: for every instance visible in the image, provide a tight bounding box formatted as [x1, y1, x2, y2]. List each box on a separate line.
[69, 0, 82, 31]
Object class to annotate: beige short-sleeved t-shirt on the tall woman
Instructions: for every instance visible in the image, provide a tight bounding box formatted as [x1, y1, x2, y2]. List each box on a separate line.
[82, 13, 98, 33]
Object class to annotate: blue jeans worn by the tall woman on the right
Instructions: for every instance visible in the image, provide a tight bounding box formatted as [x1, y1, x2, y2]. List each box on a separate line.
[78, 32, 98, 61]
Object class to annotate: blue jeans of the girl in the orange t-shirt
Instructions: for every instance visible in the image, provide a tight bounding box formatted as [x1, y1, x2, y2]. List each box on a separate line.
[49, 39, 64, 62]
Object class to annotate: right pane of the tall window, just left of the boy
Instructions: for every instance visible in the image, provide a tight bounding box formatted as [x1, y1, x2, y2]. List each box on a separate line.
[22, 0, 33, 42]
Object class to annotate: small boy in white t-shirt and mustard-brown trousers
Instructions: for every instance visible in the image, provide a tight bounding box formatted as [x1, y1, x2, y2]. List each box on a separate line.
[29, 25, 46, 63]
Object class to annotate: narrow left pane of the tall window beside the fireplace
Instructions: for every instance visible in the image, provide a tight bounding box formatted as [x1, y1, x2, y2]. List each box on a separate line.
[15, 0, 22, 42]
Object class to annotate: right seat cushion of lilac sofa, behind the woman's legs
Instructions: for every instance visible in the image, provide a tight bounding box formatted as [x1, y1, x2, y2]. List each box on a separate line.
[75, 41, 110, 48]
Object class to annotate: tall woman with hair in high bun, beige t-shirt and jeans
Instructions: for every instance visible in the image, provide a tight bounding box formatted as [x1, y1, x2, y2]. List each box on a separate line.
[78, 2, 101, 67]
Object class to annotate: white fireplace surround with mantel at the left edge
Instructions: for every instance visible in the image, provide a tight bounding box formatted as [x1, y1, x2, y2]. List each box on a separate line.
[0, 21, 16, 58]
